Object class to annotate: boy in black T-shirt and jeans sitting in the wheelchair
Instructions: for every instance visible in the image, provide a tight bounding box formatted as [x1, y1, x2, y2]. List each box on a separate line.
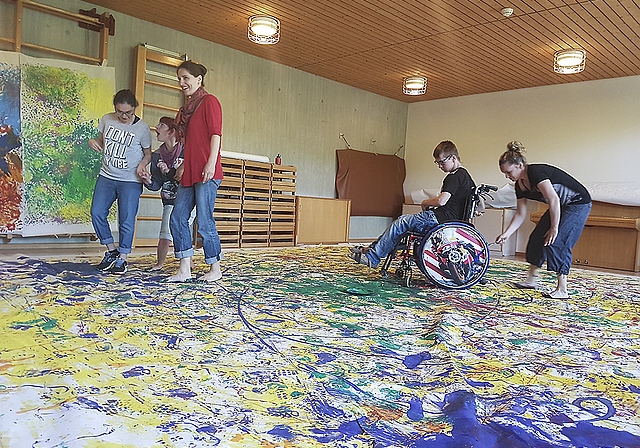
[349, 140, 484, 268]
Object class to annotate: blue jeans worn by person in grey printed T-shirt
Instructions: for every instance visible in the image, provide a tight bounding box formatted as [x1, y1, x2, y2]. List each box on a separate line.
[91, 176, 142, 254]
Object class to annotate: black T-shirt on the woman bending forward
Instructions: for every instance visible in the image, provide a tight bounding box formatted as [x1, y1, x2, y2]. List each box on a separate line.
[516, 163, 591, 205]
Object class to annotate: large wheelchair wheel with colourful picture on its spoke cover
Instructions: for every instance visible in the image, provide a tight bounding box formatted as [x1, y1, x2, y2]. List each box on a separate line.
[416, 222, 489, 289]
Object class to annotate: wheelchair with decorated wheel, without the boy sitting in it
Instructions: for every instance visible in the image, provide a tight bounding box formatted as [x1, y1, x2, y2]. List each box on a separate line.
[380, 185, 498, 289]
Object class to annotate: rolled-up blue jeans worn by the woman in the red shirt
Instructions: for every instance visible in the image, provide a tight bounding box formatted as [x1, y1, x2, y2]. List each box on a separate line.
[169, 179, 222, 264]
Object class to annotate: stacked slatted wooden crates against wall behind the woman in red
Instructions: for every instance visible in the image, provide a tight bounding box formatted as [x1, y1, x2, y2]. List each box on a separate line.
[196, 157, 296, 248]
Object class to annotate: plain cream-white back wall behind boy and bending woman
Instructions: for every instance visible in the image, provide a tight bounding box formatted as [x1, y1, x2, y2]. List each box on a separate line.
[404, 76, 640, 252]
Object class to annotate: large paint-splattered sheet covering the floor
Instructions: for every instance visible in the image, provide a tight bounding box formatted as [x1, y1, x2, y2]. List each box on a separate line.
[0, 247, 640, 448]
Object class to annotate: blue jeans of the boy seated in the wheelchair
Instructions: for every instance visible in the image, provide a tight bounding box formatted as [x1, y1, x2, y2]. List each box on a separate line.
[366, 210, 438, 266]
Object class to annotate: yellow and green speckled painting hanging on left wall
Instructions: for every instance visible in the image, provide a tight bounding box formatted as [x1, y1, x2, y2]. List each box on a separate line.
[0, 52, 115, 236]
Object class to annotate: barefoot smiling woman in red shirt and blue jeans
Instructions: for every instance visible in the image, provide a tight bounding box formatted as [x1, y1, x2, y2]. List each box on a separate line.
[167, 61, 223, 282]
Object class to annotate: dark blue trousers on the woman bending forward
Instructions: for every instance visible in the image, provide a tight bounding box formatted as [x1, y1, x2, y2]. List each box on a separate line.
[526, 203, 591, 275]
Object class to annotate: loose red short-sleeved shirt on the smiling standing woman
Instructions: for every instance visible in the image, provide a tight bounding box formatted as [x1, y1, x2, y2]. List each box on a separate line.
[180, 95, 223, 187]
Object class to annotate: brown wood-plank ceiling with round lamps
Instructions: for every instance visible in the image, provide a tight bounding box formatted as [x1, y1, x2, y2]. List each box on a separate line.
[90, 0, 640, 102]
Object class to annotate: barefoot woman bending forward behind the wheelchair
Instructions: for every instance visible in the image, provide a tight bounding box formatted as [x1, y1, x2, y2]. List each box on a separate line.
[496, 141, 591, 299]
